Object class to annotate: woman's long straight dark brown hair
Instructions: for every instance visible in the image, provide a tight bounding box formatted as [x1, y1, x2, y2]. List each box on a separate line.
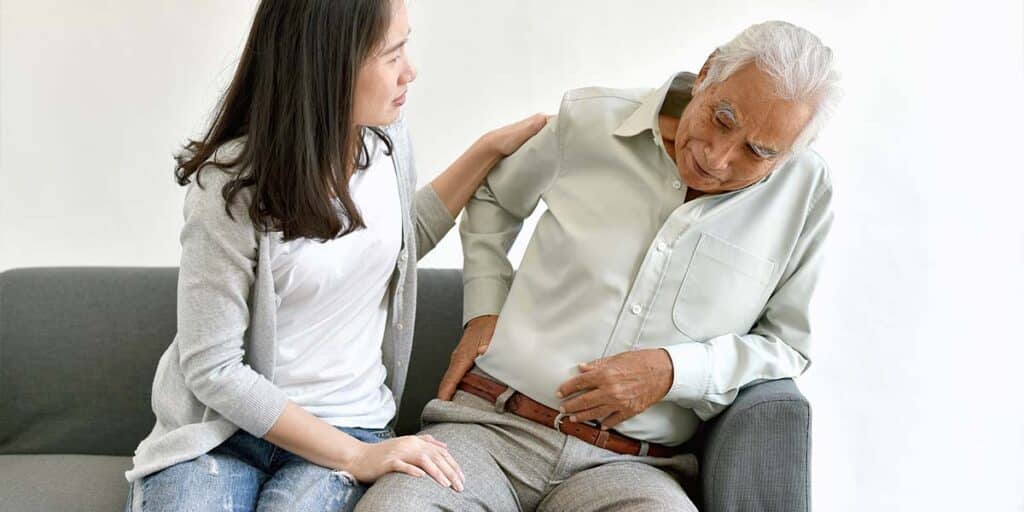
[174, 0, 400, 241]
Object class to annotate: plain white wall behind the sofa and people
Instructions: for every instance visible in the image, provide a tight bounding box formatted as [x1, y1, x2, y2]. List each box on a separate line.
[0, 0, 1024, 512]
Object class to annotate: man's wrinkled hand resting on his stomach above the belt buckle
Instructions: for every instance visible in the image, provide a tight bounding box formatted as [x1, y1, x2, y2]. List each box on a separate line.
[557, 348, 673, 429]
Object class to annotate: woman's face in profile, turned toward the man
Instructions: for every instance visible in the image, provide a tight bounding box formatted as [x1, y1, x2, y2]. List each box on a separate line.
[353, 0, 416, 126]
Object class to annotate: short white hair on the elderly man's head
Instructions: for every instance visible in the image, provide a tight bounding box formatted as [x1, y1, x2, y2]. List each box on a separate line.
[694, 22, 843, 153]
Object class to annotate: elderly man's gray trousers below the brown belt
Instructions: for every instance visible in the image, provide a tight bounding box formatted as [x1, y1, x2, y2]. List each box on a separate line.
[356, 391, 697, 511]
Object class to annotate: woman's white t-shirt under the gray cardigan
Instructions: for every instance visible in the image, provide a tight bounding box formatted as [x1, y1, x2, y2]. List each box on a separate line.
[270, 133, 401, 428]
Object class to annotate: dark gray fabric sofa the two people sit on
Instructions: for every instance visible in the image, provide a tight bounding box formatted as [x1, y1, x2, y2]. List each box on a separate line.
[0, 267, 810, 511]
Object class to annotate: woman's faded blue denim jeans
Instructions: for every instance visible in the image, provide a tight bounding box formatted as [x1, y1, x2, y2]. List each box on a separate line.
[125, 427, 394, 512]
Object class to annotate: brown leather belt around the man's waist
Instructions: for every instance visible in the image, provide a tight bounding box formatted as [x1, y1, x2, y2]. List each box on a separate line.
[459, 373, 678, 457]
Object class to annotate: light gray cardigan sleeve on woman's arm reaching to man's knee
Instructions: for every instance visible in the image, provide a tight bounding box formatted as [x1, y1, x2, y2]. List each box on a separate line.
[177, 167, 288, 437]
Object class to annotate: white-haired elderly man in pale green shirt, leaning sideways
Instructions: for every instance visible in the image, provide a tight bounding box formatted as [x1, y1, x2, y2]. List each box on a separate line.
[360, 22, 839, 511]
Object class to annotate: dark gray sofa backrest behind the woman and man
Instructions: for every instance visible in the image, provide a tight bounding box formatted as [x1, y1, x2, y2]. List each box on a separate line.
[0, 267, 462, 456]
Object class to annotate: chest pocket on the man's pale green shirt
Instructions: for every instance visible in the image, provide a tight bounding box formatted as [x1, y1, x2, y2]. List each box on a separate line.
[672, 232, 775, 341]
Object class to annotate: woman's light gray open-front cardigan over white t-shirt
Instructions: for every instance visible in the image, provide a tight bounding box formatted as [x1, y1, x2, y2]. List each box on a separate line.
[125, 120, 455, 481]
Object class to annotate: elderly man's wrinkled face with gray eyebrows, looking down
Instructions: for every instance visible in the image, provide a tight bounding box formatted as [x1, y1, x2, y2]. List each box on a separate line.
[675, 62, 812, 194]
